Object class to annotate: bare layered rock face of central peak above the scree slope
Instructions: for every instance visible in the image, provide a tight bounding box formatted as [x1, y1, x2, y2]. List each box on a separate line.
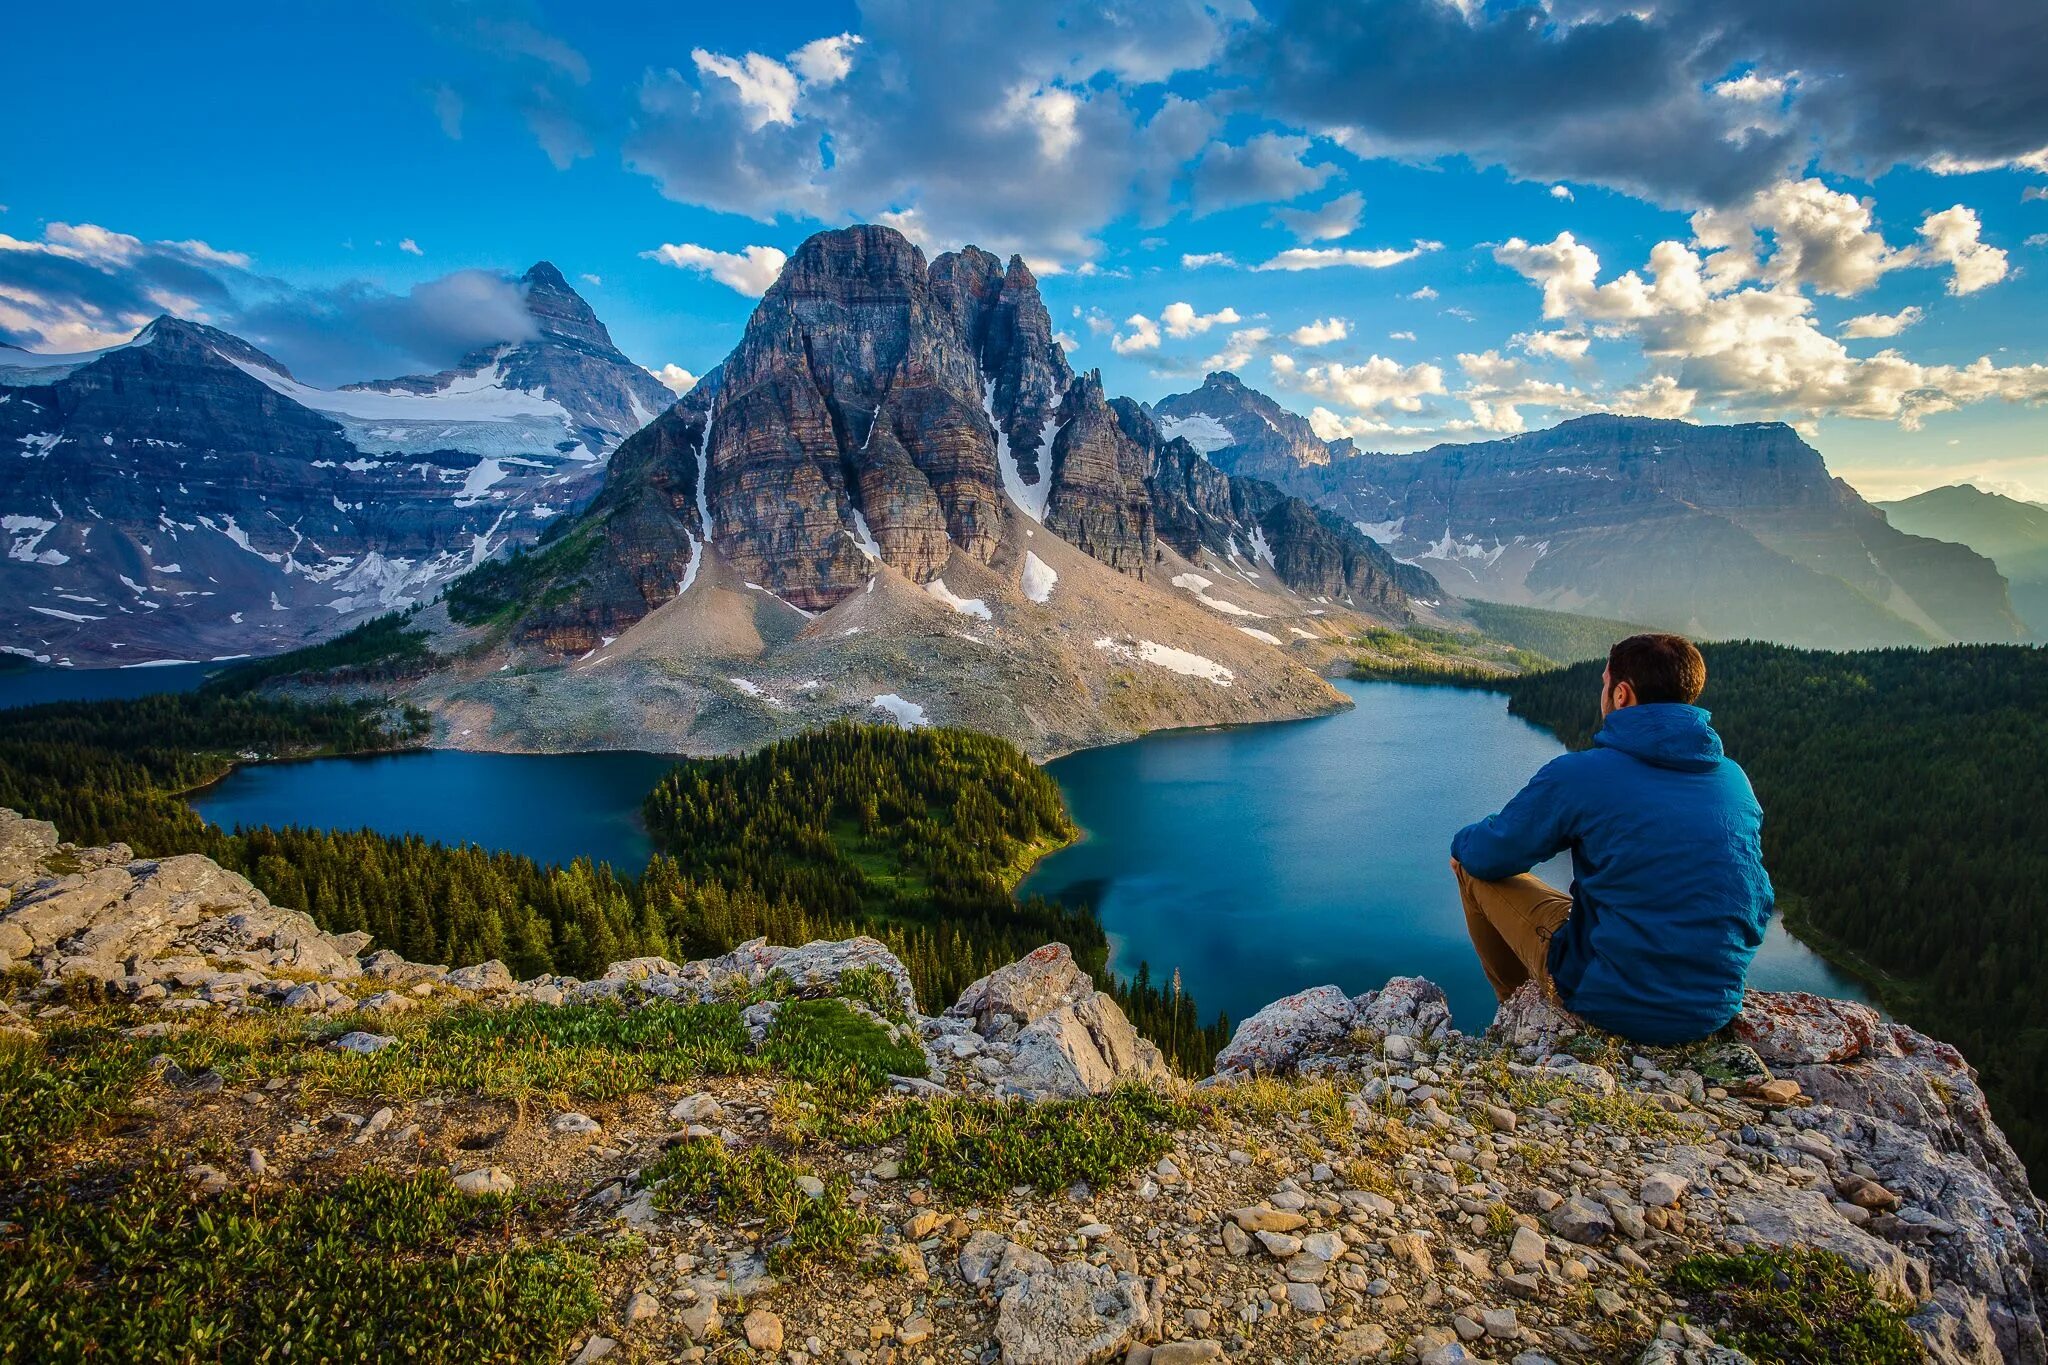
[475, 227, 1436, 655]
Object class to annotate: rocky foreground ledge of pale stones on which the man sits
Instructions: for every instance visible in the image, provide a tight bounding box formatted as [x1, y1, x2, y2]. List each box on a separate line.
[0, 812, 2048, 1365]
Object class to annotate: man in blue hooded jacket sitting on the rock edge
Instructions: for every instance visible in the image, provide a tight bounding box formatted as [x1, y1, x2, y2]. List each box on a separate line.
[1450, 634, 1772, 1046]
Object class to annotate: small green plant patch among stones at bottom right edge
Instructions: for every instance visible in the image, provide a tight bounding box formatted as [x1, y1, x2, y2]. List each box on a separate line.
[1665, 1248, 1925, 1365]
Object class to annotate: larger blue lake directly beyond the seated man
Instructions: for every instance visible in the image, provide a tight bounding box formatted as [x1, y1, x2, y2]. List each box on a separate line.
[1020, 681, 1862, 1029]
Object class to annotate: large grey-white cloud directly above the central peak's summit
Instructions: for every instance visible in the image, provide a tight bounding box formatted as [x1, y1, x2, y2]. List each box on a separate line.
[627, 0, 1236, 260]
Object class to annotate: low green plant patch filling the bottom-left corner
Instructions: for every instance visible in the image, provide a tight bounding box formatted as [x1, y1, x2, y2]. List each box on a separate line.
[0, 1169, 602, 1361]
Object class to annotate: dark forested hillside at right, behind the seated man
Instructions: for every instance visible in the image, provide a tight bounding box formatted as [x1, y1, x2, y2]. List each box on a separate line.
[1501, 643, 2048, 1171]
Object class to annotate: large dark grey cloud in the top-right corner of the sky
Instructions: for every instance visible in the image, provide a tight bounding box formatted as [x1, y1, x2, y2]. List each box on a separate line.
[1229, 0, 2048, 207]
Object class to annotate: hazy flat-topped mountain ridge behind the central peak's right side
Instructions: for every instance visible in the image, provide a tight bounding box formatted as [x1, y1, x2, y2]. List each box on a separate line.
[1155, 375, 2025, 649]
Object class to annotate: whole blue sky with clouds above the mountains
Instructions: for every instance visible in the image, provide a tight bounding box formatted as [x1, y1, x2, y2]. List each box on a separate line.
[0, 0, 2048, 499]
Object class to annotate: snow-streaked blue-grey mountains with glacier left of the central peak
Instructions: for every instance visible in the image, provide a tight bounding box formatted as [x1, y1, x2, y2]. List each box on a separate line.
[0, 264, 670, 665]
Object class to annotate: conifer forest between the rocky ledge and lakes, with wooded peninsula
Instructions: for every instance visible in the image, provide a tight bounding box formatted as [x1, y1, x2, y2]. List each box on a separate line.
[0, 692, 1229, 1074]
